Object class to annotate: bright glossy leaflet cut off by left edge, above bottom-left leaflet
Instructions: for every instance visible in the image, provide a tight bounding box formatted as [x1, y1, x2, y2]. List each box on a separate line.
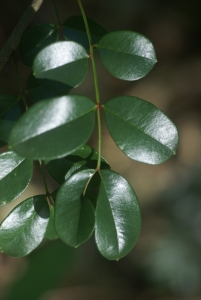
[0, 151, 33, 206]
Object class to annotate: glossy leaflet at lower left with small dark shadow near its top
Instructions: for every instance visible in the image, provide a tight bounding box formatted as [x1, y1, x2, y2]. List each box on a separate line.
[0, 195, 49, 257]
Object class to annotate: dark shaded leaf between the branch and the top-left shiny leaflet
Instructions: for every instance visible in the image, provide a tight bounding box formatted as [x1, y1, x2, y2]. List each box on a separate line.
[19, 24, 59, 66]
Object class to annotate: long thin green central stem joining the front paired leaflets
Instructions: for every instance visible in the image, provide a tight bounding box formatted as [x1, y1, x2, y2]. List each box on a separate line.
[77, 0, 102, 170]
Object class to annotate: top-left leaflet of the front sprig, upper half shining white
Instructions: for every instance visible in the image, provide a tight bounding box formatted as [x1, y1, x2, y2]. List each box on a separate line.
[33, 41, 88, 92]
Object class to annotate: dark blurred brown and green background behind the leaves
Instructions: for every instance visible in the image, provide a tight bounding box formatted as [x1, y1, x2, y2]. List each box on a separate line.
[0, 0, 201, 300]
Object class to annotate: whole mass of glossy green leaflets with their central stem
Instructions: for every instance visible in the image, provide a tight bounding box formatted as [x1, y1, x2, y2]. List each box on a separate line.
[0, 0, 178, 260]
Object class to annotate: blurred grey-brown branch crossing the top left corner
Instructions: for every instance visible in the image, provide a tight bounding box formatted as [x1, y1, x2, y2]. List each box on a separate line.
[0, 0, 44, 70]
